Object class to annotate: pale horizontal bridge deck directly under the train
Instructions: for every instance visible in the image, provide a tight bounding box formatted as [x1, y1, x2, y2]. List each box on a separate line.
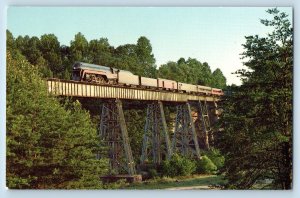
[47, 79, 218, 102]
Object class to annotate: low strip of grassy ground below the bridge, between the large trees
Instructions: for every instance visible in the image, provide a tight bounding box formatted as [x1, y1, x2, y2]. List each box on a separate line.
[122, 175, 226, 189]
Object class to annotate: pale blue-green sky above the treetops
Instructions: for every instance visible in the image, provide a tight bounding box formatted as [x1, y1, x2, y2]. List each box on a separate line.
[7, 7, 293, 85]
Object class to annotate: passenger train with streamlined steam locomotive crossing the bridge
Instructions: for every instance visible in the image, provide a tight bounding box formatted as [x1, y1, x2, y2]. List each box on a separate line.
[72, 62, 224, 96]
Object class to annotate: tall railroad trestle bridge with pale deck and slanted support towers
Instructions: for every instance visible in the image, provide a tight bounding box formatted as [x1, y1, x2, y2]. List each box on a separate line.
[47, 79, 219, 175]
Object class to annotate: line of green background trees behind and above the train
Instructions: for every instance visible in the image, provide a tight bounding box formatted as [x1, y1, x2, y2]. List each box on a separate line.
[7, 31, 226, 88]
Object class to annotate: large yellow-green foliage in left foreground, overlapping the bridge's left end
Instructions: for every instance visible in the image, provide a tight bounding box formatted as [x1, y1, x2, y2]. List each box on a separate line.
[6, 53, 108, 189]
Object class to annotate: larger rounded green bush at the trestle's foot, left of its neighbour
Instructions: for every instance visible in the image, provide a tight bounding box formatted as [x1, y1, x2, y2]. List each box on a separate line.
[163, 154, 196, 177]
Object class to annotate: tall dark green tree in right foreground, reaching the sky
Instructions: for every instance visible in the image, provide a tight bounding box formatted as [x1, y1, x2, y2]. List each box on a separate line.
[219, 9, 293, 189]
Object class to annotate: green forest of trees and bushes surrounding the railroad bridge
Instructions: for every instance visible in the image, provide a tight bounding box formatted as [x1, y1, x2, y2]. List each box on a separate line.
[6, 9, 293, 189]
